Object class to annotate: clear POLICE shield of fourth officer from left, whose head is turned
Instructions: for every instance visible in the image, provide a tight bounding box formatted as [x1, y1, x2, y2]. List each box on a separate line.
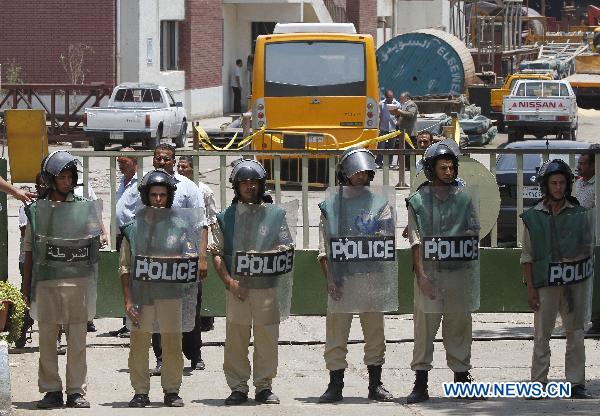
[319, 186, 398, 313]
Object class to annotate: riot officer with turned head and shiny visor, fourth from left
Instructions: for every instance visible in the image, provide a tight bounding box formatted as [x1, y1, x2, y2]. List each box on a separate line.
[318, 148, 398, 403]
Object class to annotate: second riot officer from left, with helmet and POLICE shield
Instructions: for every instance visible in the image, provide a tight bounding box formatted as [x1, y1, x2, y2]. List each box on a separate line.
[119, 169, 204, 407]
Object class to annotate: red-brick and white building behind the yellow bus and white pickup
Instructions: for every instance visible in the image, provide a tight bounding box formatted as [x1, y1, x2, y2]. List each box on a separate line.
[0, 0, 394, 119]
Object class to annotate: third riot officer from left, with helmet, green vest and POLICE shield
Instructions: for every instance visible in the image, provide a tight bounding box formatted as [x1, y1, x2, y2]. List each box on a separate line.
[210, 159, 298, 405]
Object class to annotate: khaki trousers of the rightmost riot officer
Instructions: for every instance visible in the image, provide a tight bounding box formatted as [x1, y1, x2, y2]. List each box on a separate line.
[531, 280, 591, 386]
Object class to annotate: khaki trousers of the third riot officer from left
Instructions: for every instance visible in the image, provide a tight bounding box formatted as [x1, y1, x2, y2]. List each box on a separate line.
[223, 288, 280, 394]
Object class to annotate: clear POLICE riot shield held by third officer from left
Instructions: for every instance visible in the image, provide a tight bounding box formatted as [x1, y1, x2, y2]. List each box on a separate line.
[227, 200, 298, 325]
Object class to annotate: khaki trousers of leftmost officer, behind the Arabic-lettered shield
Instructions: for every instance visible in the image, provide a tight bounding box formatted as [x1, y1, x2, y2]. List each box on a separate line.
[34, 279, 88, 394]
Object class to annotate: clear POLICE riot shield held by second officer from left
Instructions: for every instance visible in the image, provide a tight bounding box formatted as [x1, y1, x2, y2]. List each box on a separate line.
[127, 206, 204, 333]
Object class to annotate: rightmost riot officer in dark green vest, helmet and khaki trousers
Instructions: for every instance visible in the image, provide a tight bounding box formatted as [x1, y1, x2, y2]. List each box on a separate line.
[521, 159, 595, 399]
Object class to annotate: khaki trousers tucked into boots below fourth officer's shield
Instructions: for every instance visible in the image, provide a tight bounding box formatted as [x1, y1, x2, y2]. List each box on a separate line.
[324, 312, 385, 371]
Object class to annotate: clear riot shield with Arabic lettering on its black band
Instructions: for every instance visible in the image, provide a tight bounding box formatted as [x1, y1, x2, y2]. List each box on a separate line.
[31, 199, 102, 324]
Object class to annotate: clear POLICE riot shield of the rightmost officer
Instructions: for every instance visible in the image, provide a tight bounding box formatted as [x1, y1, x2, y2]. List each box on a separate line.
[532, 210, 595, 330]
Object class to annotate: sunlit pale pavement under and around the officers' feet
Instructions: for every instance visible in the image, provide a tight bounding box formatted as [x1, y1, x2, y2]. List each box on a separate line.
[10, 314, 600, 416]
